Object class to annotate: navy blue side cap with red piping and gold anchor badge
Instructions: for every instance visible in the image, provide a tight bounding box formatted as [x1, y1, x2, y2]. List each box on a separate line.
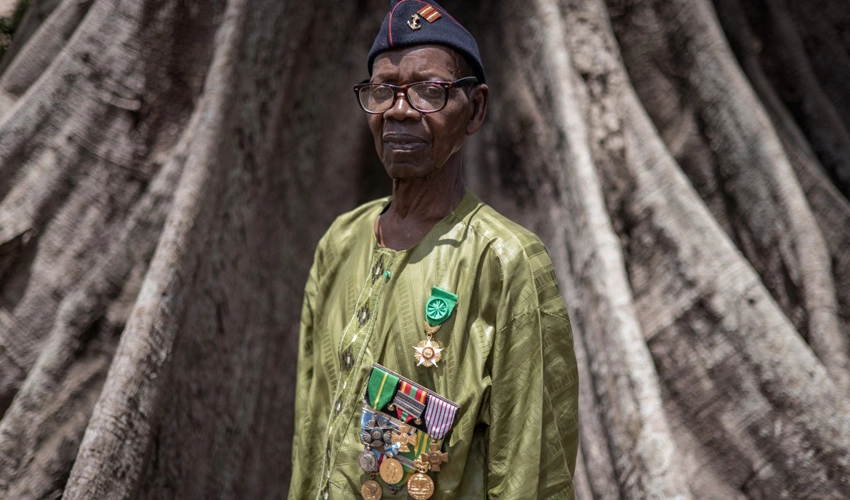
[367, 0, 484, 83]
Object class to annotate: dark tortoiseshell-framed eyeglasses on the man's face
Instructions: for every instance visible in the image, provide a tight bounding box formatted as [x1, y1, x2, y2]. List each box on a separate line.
[354, 76, 478, 114]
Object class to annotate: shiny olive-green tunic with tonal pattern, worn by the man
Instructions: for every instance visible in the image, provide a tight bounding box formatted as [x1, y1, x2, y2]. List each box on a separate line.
[289, 192, 578, 500]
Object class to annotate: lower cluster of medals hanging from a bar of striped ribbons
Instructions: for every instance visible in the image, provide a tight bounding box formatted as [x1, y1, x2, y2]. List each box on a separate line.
[358, 365, 458, 500]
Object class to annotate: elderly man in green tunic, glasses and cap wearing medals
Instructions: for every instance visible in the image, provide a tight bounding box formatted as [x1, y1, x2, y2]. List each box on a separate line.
[290, 0, 578, 500]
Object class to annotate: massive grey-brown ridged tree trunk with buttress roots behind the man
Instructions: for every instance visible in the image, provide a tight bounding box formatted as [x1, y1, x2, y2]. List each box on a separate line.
[0, 0, 850, 499]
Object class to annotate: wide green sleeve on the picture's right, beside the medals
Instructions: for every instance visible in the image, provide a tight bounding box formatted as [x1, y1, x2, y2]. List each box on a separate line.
[487, 241, 578, 500]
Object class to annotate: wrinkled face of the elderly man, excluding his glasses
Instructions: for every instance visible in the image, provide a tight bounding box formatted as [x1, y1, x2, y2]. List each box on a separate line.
[368, 45, 472, 179]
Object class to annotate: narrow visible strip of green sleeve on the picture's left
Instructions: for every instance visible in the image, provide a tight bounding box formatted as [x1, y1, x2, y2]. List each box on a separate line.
[290, 242, 322, 498]
